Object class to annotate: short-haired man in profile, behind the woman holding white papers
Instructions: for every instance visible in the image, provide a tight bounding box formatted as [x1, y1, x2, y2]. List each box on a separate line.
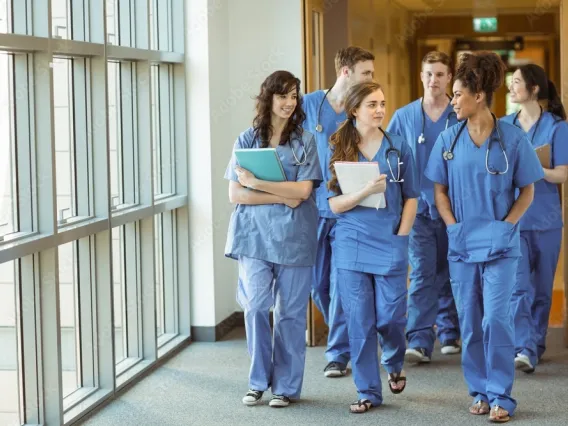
[304, 46, 375, 377]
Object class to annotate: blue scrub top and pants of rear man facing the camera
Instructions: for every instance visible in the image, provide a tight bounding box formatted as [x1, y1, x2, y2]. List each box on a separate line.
[388, 99, 460, 357]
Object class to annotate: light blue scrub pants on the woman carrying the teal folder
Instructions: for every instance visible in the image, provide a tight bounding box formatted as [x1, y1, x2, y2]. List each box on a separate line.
[237, 257, 312, 399]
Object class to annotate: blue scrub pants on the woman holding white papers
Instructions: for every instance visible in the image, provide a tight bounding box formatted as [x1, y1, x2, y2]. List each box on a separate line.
[337, 269, 407, 406]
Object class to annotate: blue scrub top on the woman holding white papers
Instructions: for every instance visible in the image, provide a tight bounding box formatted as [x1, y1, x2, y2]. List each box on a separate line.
[324, 133, 420, 275]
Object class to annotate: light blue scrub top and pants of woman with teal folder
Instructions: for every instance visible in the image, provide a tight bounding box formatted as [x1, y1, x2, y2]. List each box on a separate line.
[225, 129, 321, 398]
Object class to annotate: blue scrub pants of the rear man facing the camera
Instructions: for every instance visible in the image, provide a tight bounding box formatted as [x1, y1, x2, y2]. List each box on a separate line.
[406, 216, 460, 357]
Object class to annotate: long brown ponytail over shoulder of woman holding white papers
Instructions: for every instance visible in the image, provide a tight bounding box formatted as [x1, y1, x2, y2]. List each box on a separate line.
[327, 118, 361, 193]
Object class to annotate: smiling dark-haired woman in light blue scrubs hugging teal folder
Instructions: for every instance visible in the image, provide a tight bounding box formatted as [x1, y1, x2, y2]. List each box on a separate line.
[225, 71, 322, 407]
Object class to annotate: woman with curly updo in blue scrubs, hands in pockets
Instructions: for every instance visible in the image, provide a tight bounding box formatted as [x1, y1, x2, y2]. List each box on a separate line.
[425, 52, 544, 422]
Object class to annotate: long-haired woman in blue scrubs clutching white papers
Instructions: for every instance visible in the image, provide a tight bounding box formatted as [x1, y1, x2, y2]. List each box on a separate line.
[324, 82, 420, 413]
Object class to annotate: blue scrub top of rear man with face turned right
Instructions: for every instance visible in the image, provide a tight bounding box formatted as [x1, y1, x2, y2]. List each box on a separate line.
[303, 90, 347, 218]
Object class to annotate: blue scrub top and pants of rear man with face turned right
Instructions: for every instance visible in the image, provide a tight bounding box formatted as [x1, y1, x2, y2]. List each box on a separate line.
[303, 90, 350, 365]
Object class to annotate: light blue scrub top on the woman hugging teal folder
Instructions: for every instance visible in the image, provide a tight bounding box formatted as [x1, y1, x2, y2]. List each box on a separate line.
[225, 128, 322, 266]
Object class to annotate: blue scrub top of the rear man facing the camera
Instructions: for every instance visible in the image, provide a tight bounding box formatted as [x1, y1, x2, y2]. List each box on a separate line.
[387, 99, 458, 220]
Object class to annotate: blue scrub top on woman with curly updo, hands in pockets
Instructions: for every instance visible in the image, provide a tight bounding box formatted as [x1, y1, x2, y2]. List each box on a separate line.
[425, 121, 544, 263]
